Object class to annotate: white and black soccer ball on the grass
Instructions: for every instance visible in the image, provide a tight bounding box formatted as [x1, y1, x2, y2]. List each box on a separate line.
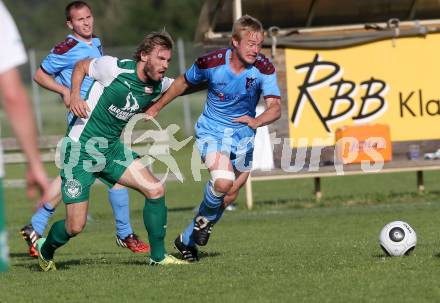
[379, 221, 417, 256]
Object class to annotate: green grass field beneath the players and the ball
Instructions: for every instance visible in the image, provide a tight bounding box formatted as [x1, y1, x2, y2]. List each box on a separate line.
[0, 149, 440, 302]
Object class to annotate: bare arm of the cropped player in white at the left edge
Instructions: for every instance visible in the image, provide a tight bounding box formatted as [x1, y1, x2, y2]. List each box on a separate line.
[0, 68, 49, 197]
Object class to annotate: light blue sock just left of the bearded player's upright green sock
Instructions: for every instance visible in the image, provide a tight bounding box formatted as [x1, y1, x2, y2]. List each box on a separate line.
[108, 188, 133, 239]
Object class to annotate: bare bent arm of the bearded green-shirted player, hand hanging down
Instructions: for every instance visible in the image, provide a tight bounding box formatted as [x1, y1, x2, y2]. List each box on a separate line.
[69, 59, 92, 118]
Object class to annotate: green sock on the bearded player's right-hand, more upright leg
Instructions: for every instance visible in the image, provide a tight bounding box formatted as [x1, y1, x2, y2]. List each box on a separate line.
[143, 196, 167, 262]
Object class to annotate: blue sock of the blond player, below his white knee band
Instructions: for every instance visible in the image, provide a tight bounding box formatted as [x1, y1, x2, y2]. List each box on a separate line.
[182, 181, 224, 246]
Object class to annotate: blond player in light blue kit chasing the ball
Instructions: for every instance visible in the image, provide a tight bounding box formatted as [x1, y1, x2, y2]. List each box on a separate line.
[146, 15, 281, 261]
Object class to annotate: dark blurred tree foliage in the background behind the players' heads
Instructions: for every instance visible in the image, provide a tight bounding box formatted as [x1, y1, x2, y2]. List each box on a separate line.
[3, 0, 203, 49]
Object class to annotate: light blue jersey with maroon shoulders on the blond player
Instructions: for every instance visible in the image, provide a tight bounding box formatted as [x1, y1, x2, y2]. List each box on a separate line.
[185, 49, 280, 128]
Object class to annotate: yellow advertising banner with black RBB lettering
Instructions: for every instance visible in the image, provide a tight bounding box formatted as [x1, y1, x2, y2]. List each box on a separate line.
[285, 34, 440, 147]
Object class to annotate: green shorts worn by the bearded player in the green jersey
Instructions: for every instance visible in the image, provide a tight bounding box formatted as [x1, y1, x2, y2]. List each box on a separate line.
[60, 141, 138, 204]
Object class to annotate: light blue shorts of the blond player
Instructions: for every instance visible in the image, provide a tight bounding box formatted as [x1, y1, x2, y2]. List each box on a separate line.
[195, 115, 255, 172]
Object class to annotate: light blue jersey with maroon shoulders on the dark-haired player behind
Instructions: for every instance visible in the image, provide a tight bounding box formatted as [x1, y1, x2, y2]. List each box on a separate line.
[40, 35, 102, 98]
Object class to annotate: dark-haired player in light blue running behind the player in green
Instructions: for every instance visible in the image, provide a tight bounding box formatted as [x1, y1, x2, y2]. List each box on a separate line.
[20, 1, 149, 257]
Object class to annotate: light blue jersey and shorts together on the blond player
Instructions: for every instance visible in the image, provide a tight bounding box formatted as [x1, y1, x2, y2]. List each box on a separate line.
[185, 49, 280, 171]
